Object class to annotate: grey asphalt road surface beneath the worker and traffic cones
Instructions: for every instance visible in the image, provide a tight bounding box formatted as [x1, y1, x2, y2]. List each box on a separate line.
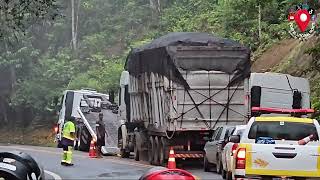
[0, 145, 221, 180]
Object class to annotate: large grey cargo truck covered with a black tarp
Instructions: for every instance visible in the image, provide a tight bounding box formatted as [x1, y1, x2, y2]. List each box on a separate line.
[118, 33, 251, 165]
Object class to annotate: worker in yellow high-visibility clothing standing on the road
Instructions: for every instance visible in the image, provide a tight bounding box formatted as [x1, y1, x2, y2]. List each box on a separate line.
[61, 118, 76, 166]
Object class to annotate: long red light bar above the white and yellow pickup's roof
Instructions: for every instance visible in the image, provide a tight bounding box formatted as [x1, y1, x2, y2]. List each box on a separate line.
[251, 107, 315, 115]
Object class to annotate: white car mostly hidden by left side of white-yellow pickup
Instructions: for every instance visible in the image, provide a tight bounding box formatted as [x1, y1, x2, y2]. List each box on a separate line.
[222, 125, 246, 180]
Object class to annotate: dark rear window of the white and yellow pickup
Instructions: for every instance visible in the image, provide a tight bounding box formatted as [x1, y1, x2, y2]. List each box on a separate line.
[248, 121, 318, 141]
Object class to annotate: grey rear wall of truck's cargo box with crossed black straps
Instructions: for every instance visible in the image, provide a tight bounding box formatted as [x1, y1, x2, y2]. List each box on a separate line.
[168, 71, 250, 131]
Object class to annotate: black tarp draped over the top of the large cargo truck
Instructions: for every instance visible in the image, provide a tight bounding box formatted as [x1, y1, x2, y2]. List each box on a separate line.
[125, 32, 251, 87]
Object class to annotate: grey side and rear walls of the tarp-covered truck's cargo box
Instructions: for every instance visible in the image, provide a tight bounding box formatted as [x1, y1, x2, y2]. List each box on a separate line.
[129, 47, 250, 133]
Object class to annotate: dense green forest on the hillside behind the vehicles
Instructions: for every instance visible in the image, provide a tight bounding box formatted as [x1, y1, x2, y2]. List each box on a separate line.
[0, 0, 320, 125]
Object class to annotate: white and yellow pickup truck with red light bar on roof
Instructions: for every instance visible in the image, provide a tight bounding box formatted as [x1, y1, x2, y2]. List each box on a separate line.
[229, 117, 320, 179]
